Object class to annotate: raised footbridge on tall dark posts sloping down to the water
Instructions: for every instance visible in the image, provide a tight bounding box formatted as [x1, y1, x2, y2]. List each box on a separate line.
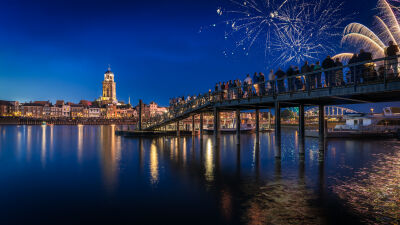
[134, 55, 400, 158]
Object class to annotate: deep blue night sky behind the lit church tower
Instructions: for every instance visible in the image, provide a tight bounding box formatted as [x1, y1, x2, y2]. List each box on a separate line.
[0, 0, 396, 112]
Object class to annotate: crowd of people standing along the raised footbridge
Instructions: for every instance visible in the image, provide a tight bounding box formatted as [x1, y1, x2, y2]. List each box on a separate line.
[170, 41, 399, 108]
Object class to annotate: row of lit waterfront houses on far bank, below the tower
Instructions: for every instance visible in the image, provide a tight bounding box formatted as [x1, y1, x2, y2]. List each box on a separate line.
[0, 100, 167, 119]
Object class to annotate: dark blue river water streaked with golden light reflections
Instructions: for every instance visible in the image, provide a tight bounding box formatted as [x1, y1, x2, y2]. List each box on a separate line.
[0, 126, 400, 224]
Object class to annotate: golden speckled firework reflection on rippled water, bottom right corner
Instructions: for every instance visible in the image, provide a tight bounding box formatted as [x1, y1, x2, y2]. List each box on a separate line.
[332, 143, 400, 224]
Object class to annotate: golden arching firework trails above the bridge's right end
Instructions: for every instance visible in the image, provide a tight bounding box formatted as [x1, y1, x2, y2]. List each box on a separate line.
[335, 0, 400, 60]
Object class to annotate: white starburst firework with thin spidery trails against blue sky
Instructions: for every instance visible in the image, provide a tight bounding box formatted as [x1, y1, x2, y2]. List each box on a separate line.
[215, 0, 346, 65]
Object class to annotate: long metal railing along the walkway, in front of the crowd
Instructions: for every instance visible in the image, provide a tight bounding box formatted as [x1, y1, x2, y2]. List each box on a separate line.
[145, 56, 400, 130]
